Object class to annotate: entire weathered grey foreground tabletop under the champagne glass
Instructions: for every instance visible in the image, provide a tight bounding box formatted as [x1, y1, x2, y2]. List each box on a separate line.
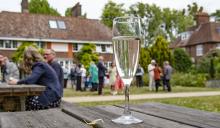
[0, 102, 220, 128]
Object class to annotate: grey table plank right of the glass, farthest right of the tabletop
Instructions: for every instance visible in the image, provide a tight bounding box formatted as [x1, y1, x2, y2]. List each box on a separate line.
[121, 103, 220, 128]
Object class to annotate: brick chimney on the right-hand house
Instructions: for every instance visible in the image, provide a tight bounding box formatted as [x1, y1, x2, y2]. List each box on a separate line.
[196, 12, 209, 26]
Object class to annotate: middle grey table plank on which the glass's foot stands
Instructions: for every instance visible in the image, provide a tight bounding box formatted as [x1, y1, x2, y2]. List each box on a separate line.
[63, 101, 195, 128]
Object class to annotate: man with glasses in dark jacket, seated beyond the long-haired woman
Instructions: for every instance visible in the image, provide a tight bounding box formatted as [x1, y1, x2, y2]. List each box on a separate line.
[44, 49, 64, 96]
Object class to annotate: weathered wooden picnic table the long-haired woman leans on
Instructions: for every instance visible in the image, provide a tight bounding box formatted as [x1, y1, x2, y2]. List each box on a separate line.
[0, 83, 45, 111]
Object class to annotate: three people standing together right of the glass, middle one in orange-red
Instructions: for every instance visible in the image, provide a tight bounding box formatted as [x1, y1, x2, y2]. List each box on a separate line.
[148, 60, 172, 92]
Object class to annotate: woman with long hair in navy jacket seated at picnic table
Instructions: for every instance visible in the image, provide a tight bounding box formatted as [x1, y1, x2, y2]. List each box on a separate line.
[9, 47, 62, 110]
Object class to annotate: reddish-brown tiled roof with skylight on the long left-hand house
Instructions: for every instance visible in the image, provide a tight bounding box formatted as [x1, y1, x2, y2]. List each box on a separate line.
[0, 12, 112, 41]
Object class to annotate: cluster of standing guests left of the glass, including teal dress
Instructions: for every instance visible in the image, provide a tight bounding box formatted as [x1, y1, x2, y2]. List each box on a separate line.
[70, 56, 123, 95]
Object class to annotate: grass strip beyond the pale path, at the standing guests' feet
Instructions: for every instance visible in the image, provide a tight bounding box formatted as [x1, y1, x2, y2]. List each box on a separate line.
[64, 86, 220, 97]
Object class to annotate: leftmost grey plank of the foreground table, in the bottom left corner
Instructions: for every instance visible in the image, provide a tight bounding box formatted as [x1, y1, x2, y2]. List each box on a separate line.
[0, 109, 90, 128]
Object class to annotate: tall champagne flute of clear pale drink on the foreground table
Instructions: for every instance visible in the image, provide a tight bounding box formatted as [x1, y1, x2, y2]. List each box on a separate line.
[112, 17, 143, 124]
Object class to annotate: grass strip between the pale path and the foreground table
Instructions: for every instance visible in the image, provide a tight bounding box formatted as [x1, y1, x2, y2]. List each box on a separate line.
[80, 96, 220, 113]
